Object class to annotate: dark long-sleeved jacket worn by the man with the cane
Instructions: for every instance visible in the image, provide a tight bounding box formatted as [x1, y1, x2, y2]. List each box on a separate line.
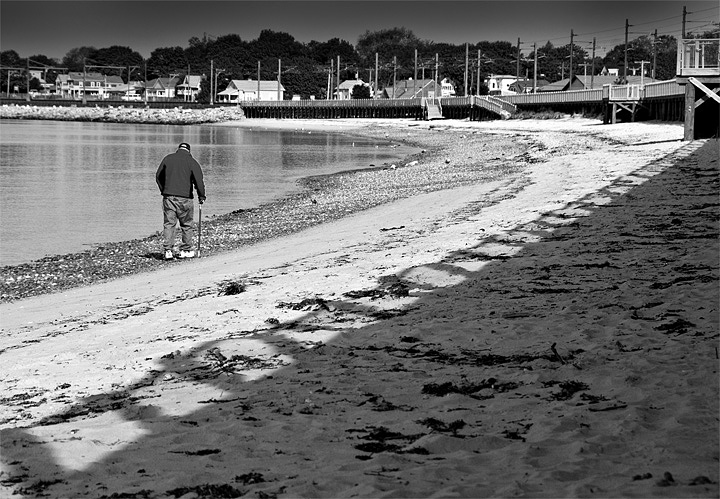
[155, 149, 205, 201]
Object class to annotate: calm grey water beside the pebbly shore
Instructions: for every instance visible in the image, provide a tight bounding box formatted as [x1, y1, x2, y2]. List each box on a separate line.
[0, 120, 414, 265]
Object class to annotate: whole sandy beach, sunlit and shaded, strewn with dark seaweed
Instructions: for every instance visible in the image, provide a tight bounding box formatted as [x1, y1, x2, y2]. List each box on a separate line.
[0, 117, 720, 499]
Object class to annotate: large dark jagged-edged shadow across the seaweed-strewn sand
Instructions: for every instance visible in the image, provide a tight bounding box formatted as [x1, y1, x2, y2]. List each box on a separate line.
[2, 141, 720, 498]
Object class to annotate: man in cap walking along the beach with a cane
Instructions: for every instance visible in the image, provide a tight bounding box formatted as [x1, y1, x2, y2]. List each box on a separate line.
[155, 142, 205, 260]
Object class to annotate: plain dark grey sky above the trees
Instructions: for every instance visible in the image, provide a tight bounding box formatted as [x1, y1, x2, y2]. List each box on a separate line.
[0, 0, 720, 59]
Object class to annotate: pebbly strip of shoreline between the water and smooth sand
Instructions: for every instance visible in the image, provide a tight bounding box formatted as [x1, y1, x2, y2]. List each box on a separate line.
[0, 120, 522, 303]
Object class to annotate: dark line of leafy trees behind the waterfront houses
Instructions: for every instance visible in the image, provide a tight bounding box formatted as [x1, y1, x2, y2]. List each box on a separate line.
[0, 27, 717, 100]
